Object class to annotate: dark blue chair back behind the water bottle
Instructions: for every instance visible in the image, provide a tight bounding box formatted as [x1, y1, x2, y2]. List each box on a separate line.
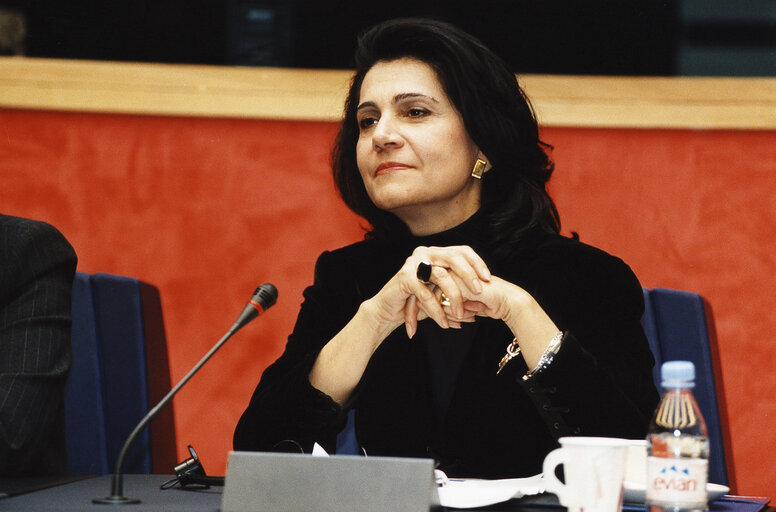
[641, 288, 729, 485]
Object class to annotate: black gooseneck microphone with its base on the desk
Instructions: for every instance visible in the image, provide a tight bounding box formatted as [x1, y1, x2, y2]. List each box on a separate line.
[92, 283, 278, 505]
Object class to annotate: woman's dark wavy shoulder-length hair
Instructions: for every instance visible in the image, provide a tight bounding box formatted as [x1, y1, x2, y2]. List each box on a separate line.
[332, 18, 560, 255]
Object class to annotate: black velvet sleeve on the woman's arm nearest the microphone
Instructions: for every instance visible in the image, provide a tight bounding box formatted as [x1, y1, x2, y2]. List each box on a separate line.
[234, 253, 358, 453]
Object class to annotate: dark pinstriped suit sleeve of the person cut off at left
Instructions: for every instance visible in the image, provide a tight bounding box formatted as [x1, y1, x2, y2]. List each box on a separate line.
[0, 215, 76, 476]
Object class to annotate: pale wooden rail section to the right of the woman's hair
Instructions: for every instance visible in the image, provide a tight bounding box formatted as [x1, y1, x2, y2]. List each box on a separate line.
[520, 76, 776, 129]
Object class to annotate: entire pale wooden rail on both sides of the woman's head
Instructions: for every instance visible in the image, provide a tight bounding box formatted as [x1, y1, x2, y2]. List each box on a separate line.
[0, 57, 776, 129]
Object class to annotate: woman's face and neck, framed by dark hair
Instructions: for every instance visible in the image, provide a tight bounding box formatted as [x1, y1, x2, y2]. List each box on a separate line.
[356, 58, 484, 235]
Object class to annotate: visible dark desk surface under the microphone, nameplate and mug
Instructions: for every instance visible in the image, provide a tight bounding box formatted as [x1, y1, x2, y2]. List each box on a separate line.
[0, 475, 774, 512]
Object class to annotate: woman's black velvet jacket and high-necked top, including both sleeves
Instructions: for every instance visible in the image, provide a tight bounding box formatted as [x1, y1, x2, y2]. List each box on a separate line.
[234, 215, 658, 478]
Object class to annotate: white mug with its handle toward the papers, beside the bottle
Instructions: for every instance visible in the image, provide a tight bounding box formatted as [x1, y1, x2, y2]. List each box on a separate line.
[544, 437, 629, 512]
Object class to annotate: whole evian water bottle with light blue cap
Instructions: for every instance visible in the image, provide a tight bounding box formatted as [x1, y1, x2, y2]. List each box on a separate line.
[646, 361, 709, 512]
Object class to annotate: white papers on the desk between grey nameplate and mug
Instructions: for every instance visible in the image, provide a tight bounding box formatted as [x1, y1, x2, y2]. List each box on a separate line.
[438, 474, 544, 508]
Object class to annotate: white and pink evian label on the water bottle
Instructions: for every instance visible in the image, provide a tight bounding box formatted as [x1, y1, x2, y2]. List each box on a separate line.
[646, 456, 709, 504]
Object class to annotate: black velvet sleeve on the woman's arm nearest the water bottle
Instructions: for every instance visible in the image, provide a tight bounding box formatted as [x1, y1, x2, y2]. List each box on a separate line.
[523, 243, 658, 439]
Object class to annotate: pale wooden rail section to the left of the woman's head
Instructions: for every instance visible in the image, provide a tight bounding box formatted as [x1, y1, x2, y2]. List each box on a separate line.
[0, 57, 348, 120]
